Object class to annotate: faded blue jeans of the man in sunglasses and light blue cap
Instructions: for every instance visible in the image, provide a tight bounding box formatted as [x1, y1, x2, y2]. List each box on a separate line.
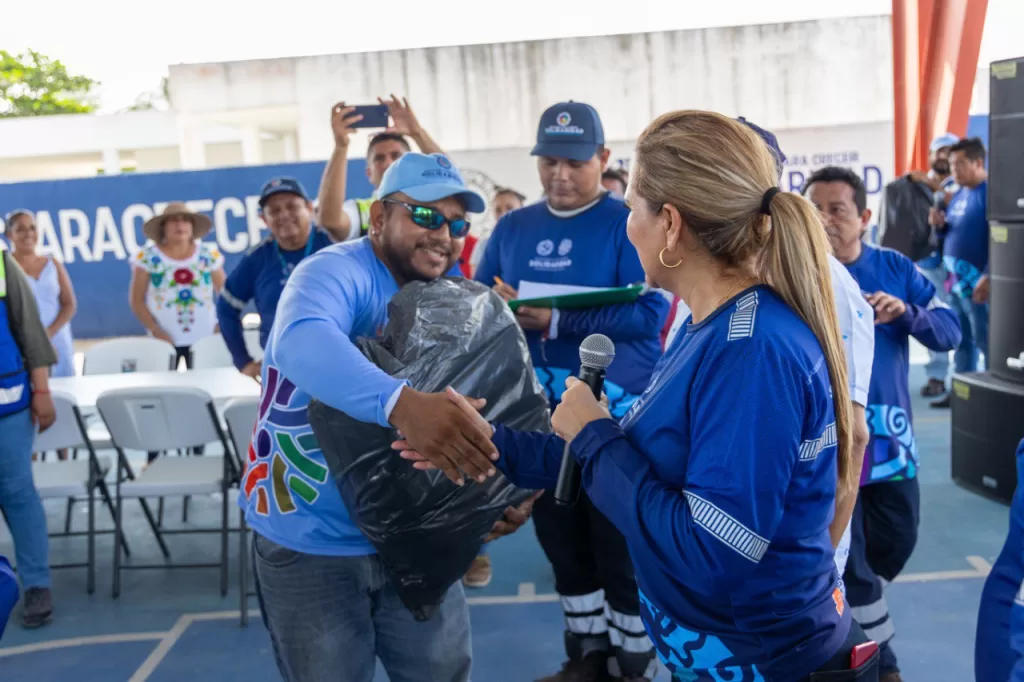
[253, 534, 472, 682]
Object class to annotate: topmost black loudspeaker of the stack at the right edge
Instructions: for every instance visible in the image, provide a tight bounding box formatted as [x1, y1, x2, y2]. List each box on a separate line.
[988, 57, 1024, 222]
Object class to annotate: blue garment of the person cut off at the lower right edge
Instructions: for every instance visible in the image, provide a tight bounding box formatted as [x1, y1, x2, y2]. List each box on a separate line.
[974, 440, 1024, 682]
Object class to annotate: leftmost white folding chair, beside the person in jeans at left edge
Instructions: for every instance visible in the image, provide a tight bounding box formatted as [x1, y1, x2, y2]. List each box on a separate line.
[32, 391, 120, 594]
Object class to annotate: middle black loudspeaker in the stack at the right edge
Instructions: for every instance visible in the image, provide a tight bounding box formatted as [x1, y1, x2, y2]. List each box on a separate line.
[986, 223, 1024, 383]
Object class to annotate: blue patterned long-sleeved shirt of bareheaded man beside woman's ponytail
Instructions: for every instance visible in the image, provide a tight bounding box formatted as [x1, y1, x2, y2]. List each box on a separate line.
[846, 244, 961, 485]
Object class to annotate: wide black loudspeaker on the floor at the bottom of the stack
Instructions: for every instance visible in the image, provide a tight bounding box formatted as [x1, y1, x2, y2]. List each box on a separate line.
[952, 373, 1024, 505]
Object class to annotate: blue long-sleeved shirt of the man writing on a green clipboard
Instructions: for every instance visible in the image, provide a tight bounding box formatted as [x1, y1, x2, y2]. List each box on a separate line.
[475, 195, 669, 416]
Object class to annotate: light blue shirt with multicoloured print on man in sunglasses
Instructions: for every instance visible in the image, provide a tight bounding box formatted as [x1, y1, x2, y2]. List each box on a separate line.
[239, 238, 413, 556]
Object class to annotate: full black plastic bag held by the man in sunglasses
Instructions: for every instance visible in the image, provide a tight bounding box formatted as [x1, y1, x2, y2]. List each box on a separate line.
[309, 278, 550, 621]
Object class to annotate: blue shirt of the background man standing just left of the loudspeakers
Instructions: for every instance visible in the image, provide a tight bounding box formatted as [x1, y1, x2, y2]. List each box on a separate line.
[942, 182, 988, 298]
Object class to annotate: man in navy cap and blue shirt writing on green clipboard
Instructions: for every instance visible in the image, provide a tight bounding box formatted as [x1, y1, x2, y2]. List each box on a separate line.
[475, 101, 669, 682]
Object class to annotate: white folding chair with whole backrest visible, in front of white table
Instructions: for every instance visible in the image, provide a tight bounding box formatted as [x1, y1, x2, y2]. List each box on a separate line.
[96, 387, 237, 597]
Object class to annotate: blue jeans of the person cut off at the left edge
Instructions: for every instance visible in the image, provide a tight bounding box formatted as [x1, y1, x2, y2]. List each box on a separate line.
[0, 410, 50, 589]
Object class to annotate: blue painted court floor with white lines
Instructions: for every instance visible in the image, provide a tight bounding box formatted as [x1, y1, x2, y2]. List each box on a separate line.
[0, 367, 1012, 682]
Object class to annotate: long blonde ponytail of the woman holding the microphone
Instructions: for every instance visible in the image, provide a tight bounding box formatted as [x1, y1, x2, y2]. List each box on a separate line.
[760, 191, 859, 498]
